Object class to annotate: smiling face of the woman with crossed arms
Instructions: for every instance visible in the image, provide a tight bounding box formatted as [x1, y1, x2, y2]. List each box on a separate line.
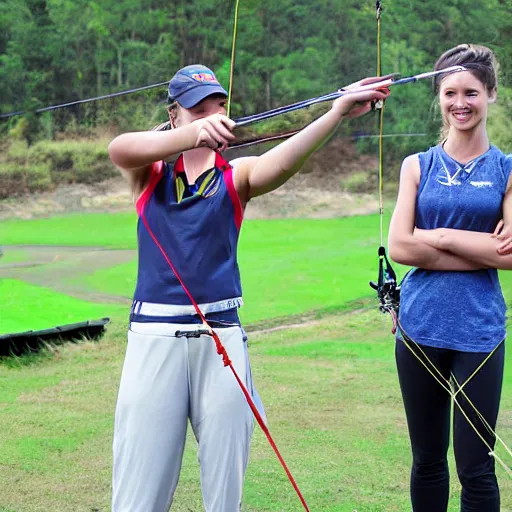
[439, 71, 496, 136]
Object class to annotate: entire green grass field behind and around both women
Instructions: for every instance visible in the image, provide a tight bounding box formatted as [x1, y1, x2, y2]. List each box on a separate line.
[0, 210, 512, 512]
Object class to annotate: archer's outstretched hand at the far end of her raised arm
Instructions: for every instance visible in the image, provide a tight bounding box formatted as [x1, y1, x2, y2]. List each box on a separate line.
[332, 75, 393, 119]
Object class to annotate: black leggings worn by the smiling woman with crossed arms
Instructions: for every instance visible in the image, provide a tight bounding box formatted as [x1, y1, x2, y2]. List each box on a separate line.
[396, 340, 505, 512]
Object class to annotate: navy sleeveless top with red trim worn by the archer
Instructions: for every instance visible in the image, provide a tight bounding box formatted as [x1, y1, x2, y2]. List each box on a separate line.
[134, 150, 243, 309]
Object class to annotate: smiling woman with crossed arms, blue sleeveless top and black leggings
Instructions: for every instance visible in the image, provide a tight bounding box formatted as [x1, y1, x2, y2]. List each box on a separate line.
[389, 44, 512, 512]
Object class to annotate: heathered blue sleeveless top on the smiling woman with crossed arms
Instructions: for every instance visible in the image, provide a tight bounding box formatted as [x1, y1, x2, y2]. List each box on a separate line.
[400, 145, 512, 352]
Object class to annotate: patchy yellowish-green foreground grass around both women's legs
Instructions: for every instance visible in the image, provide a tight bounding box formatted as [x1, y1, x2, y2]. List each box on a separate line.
[0, 309, 512, 512]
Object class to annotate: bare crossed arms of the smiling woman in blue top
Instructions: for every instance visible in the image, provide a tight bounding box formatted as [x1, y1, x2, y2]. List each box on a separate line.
[388, 155, 512, 271]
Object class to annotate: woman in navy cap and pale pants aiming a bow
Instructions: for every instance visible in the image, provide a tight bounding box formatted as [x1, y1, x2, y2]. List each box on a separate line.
[109, 65, 389, 512]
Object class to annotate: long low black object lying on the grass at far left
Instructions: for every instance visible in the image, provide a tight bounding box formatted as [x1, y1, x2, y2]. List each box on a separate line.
[0, 318, 110, 356]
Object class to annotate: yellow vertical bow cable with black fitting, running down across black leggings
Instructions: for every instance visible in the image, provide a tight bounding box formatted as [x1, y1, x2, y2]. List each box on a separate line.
[370, 0, 512, 477]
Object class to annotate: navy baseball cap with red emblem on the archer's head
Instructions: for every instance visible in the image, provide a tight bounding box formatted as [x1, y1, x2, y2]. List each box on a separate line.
[168, 64, 228, 108]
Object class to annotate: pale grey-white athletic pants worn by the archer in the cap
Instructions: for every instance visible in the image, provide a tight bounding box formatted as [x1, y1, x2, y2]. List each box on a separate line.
[112, 322, 262, 512]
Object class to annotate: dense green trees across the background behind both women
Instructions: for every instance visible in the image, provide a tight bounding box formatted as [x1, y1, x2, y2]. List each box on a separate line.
[0, 0, 512, 157]
